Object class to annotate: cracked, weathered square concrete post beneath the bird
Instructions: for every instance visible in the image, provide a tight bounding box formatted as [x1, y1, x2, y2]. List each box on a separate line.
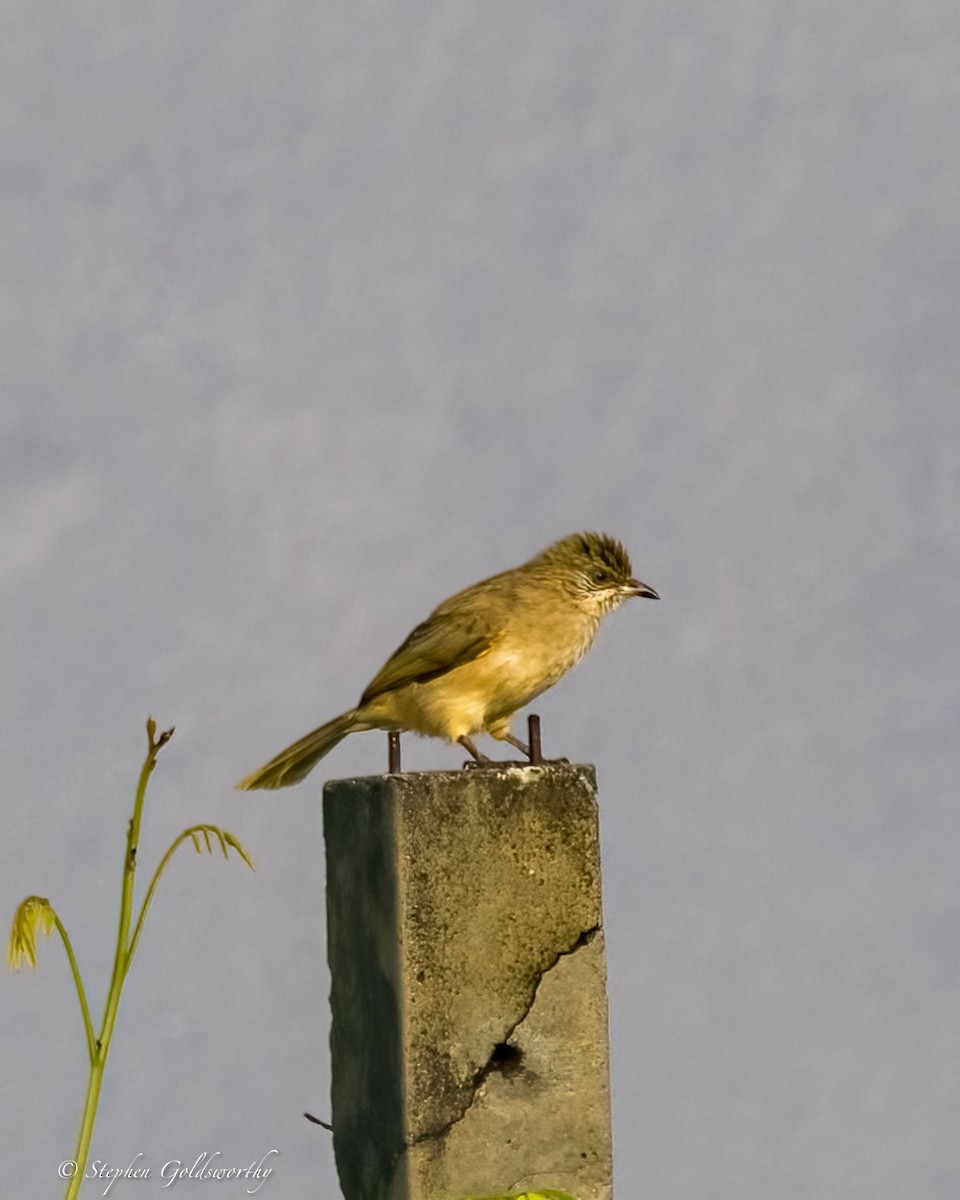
[324, 764, 612, 1200]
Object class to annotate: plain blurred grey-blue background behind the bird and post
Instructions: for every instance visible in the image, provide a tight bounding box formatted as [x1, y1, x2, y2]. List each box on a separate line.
[0, 0, 960, 1200]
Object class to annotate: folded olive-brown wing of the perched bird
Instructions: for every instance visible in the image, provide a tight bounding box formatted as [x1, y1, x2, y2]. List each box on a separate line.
[360, 588, 503, 707]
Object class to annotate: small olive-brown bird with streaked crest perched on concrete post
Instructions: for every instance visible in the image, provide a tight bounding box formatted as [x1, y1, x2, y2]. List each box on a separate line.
[236, 533, 660, 791]
